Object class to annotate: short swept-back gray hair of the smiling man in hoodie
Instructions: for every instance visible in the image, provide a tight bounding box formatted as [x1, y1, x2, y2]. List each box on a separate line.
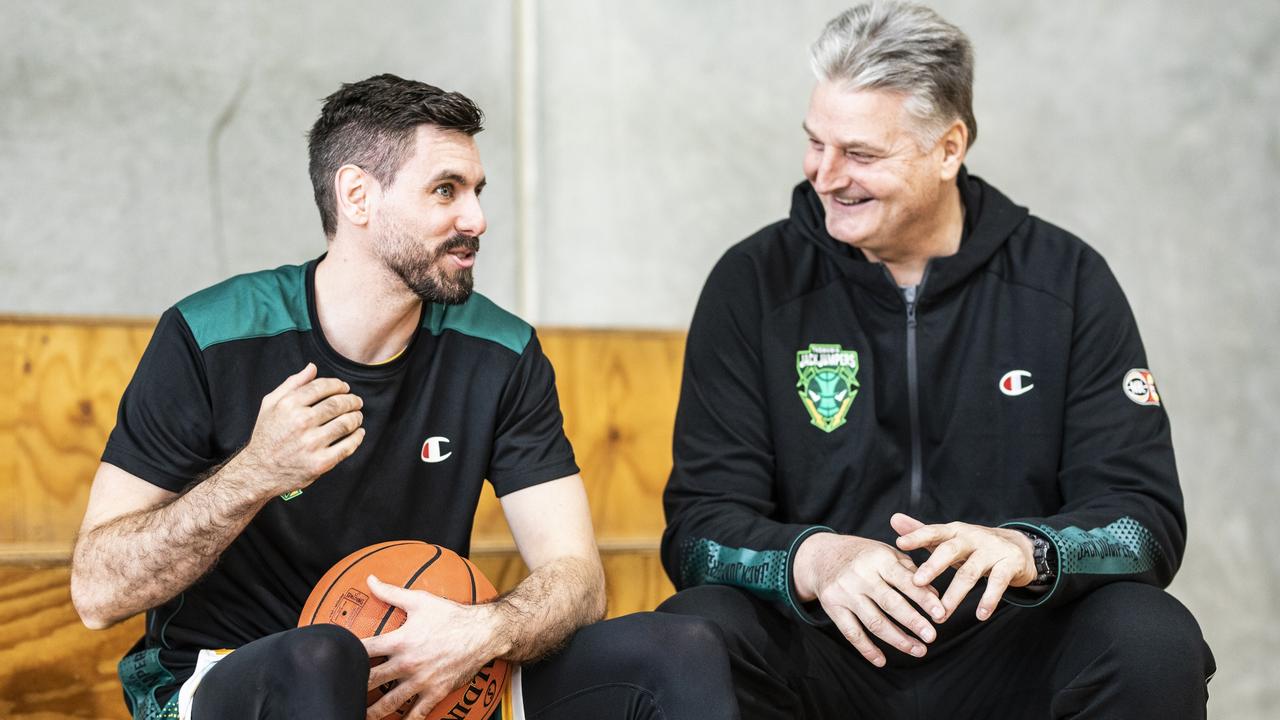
[809, 3, 978, 149]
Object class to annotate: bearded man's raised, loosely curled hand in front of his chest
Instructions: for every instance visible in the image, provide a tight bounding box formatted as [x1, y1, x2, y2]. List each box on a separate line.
[237, 363, 365, 497]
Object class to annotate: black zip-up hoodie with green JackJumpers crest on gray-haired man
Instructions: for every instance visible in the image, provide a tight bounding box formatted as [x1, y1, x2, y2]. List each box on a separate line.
[662, 165, 1185, 634]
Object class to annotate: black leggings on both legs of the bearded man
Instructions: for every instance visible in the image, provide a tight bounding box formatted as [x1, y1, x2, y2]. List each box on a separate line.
[192, 612, 737, 720]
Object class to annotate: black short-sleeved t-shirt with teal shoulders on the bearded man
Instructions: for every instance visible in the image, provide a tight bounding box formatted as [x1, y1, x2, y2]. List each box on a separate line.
[102, 254, 577, 694]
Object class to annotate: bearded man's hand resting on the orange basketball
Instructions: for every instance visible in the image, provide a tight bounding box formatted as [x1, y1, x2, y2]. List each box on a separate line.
[361, 575, 502, 720]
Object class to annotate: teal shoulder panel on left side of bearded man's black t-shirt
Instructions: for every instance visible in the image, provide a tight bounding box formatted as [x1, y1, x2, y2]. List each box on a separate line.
[178, 265, 311, 350]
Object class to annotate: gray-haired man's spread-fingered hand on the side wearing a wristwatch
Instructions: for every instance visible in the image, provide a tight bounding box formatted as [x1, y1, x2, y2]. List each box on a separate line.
[890, 512, 1036, 620]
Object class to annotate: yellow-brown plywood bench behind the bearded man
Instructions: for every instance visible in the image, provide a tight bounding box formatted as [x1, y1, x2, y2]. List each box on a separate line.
[0, 316, 684, 720]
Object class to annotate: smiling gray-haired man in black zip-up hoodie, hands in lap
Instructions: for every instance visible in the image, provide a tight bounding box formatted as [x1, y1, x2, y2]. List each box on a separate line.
[659, 4, 1215, 717]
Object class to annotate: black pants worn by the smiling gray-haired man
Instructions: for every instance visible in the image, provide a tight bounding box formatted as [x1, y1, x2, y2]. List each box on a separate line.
[658, 583, 1215, 720]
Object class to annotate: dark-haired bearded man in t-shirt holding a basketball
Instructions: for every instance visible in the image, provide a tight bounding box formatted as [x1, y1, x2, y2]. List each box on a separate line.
[72, 76, 735, 720]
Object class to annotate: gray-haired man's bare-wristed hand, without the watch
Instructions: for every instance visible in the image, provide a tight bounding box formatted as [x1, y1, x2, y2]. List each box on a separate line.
[792, 533, 946, 667]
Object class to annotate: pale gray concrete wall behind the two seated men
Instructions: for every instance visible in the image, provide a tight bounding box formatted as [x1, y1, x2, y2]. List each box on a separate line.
[0, 0, 1280, 719]
